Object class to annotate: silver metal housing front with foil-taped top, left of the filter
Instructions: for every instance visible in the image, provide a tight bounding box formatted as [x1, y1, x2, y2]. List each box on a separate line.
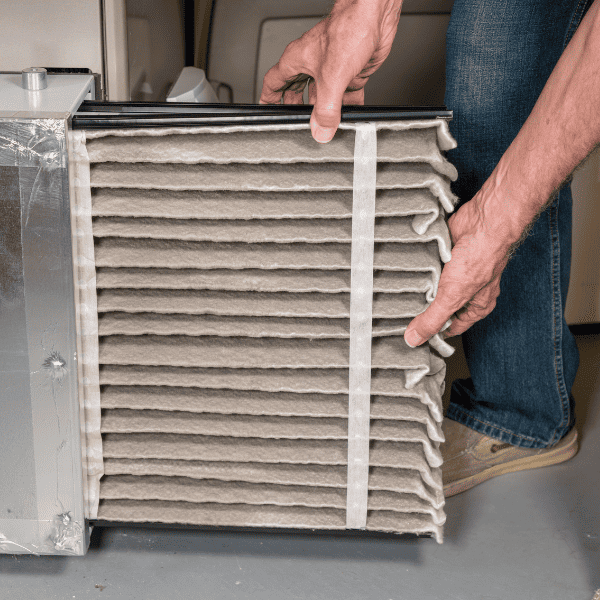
[0, 113, 89, 555]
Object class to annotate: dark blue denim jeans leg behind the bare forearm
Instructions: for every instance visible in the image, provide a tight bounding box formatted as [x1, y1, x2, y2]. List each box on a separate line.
[445, 0, 592, 448]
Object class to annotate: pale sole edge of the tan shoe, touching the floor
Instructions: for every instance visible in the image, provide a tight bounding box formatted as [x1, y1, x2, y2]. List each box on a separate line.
[442, 429, 579, 498]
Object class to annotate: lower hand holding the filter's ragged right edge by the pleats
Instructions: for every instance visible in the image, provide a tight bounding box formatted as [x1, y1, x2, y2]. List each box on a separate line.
[404, 197, 511, 347]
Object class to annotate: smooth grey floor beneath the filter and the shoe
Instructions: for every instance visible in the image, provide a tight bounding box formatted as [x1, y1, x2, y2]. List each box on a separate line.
[0, 335, 600, 600]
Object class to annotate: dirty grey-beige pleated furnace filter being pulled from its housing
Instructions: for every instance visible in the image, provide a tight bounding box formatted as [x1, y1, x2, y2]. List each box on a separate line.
[71, 119, 457, 542]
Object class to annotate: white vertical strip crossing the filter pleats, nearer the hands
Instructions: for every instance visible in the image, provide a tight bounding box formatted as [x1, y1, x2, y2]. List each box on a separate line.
[346, 123, 377, 529]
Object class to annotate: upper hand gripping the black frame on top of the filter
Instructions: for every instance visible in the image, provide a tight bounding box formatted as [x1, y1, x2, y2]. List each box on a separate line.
[260, 0, 402, 143]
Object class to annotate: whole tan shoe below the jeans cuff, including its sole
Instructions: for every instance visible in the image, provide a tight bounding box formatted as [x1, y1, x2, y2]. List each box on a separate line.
[440, 419, 579, 498]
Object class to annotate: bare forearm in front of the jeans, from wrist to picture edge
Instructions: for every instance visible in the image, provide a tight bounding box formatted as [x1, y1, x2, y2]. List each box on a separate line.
[474, 0, 600, 250]
